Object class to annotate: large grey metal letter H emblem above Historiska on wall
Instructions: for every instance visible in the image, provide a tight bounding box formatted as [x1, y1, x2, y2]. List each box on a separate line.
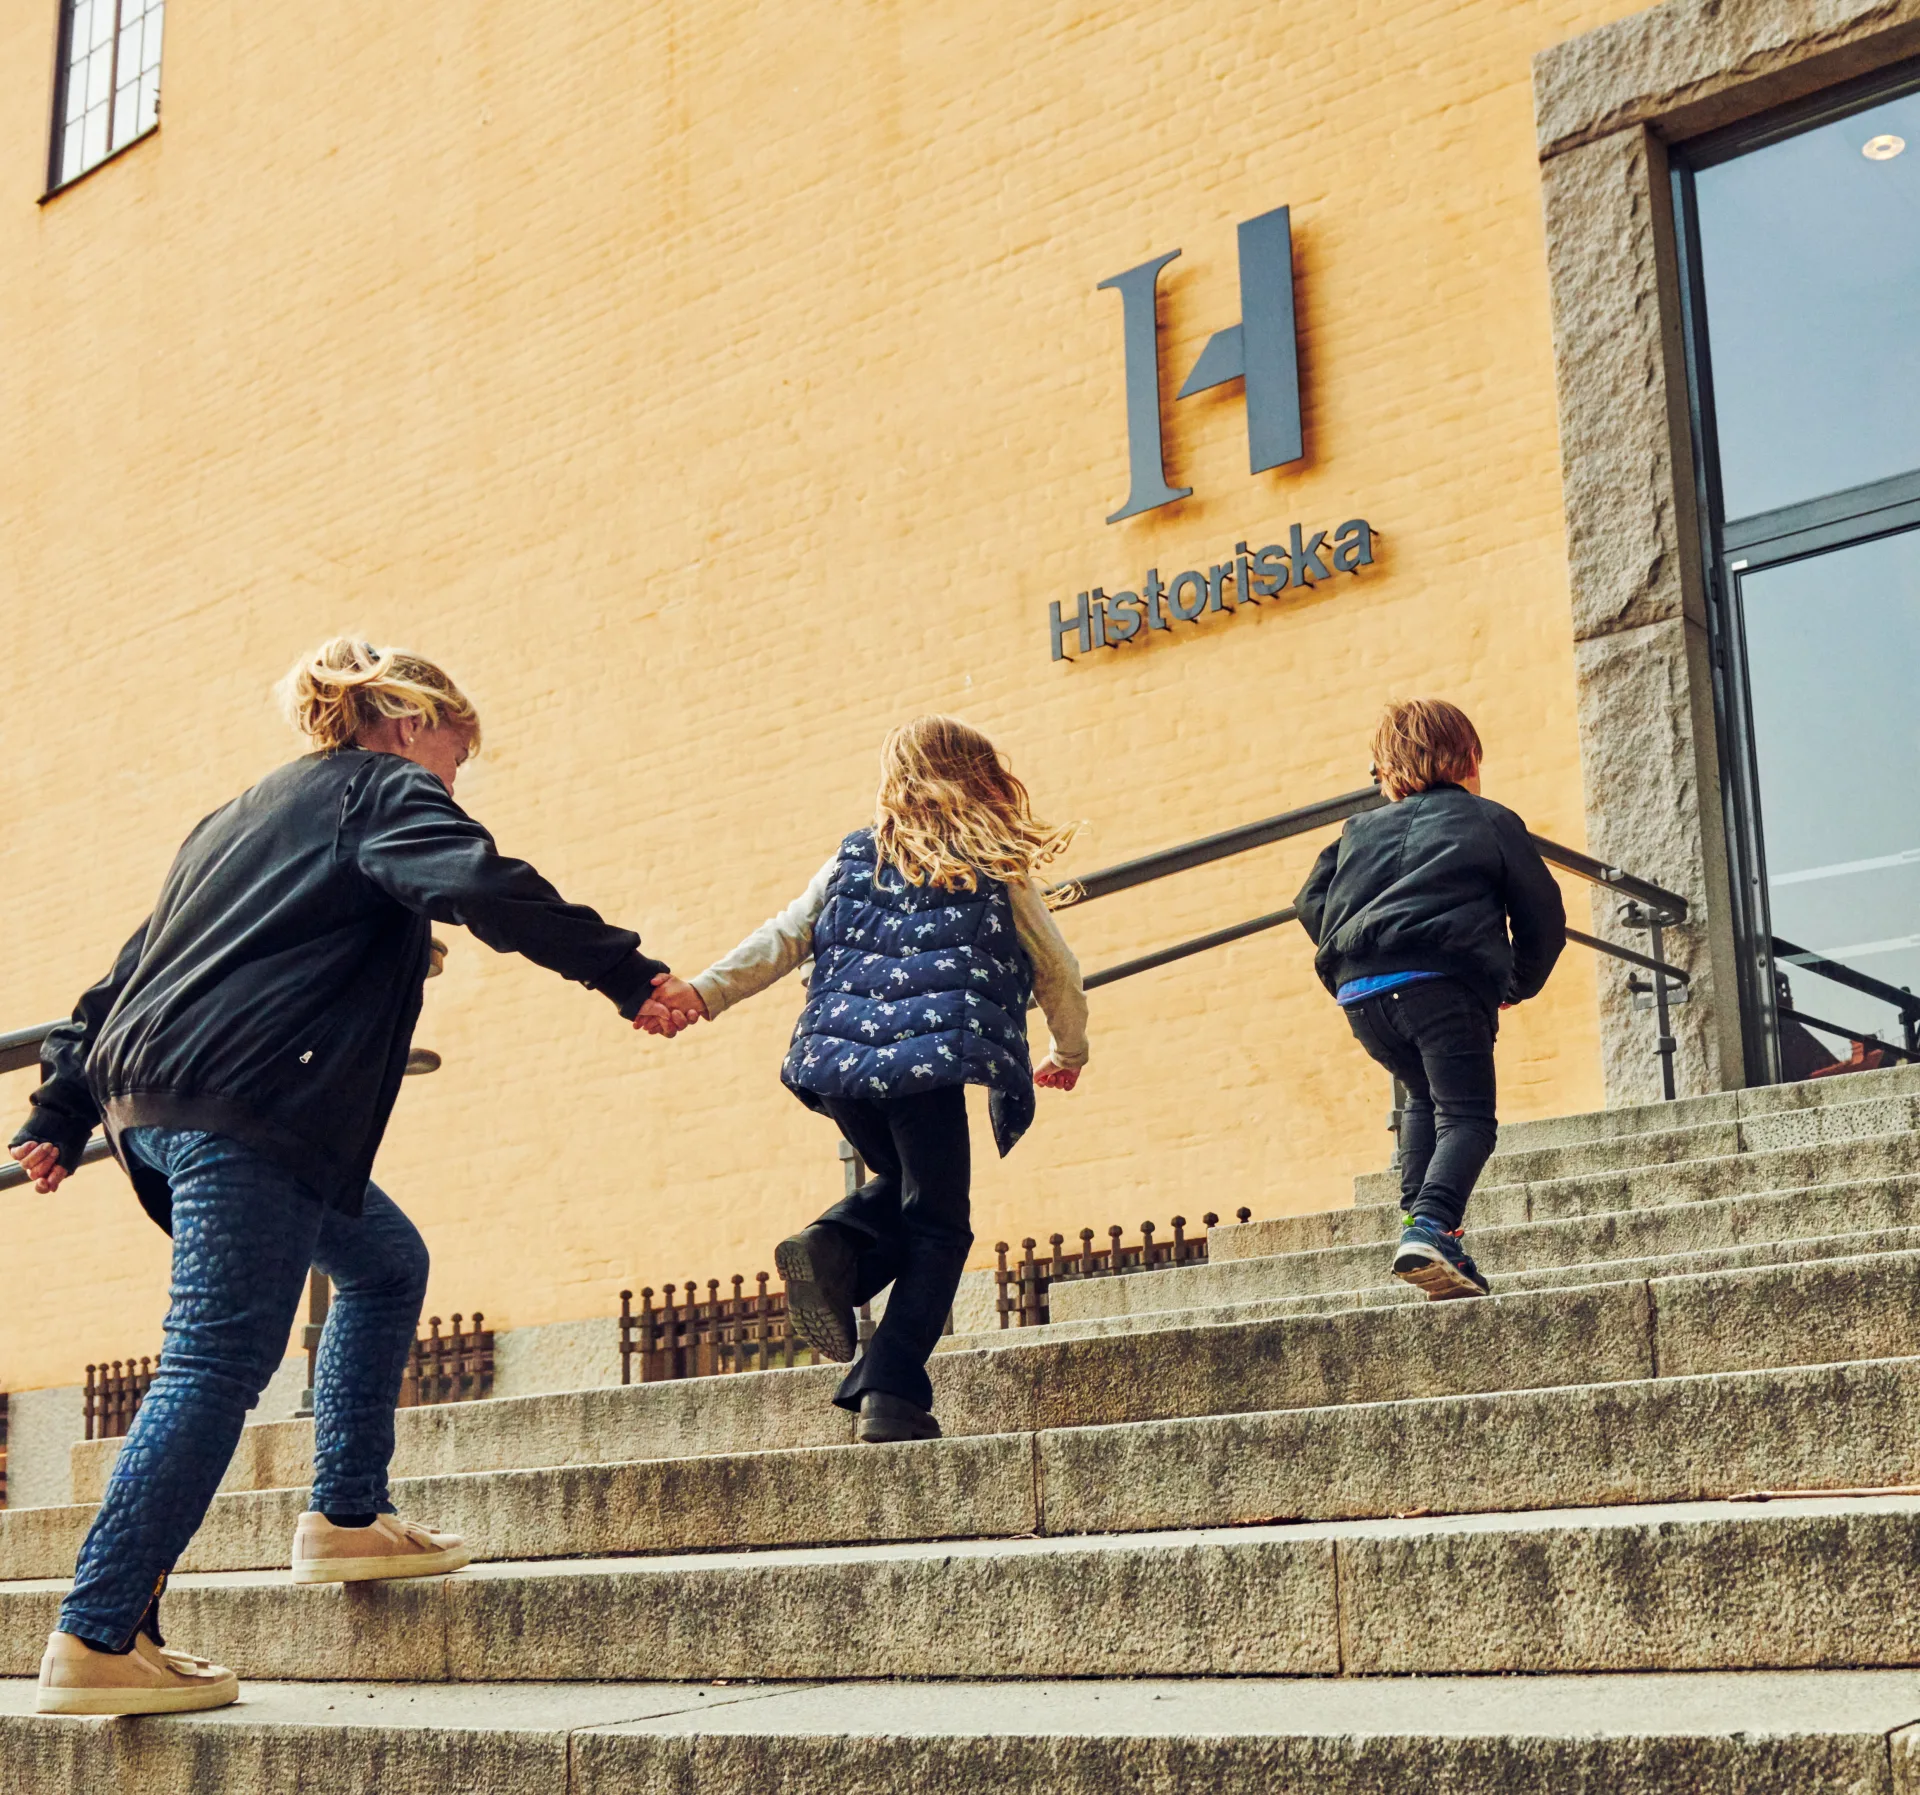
[1100, 205, 1306, 524]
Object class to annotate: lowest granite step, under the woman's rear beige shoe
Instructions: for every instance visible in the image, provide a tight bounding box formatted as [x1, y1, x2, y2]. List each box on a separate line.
[15, 1670, 1920, 1795]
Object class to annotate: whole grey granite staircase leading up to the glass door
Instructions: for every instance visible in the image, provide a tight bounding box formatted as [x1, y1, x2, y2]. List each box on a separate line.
[0, 1069, 1920, 1795]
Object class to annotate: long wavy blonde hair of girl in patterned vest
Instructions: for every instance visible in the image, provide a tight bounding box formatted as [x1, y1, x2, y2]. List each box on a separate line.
[874, 716, 1079, 906]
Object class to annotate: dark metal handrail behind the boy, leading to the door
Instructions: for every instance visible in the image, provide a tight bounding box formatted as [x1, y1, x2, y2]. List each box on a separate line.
[1046, 785, 1697, 1100]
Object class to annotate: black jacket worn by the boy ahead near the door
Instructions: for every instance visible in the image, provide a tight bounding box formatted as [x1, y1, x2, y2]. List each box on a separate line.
[1294, 785, 1567, 1008]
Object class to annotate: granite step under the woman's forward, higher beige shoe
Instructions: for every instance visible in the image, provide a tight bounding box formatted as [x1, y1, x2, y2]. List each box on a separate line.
[0, 1496, 1920, 1682]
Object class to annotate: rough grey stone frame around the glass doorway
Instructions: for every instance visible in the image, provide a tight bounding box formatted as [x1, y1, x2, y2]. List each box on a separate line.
[1534, 0, 1920, 1106]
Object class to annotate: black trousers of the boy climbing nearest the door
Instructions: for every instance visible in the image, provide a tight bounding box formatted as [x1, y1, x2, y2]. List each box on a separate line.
[1346, 979, 1500, 1231]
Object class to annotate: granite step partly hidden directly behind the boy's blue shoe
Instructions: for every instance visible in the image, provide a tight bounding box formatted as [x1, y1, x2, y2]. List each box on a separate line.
[1044, 1179, 1920, 1338]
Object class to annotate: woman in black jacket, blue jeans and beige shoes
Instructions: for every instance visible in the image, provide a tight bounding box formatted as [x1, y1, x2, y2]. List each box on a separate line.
[10, 635, 676, 1714]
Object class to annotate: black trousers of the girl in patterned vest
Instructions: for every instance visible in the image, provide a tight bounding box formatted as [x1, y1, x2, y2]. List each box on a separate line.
[820, 1085, 973, 1409]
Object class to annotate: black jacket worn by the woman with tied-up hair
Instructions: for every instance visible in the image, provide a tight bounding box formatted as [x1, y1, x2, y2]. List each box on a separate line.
[13, 749, 666, 1227]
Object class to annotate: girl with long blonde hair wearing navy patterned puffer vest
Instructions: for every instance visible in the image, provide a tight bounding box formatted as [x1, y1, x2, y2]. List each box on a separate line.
[637, 716, 1087, 1442]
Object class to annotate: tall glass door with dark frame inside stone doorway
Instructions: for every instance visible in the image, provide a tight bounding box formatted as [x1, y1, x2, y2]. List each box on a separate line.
[1674, 65, 1920, 1083]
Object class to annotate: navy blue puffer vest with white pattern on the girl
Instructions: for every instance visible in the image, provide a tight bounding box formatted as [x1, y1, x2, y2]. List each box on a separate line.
[780, 829, 1033, 1154]
